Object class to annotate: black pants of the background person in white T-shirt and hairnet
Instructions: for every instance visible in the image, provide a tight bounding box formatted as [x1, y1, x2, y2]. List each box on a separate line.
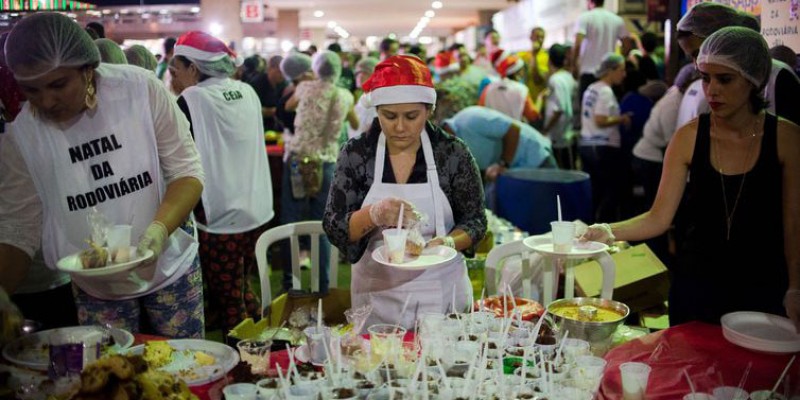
[578, 146, 630, 222]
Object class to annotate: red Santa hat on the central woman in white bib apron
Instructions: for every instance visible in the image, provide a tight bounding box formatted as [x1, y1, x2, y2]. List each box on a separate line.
[359, 55, 436, 107]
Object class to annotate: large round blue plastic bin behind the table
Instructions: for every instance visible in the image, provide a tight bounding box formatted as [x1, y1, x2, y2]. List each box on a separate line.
[495, 168, 594, 235]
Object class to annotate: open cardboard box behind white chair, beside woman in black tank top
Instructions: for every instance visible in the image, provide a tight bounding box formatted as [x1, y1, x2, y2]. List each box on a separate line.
[575, 243, 669, 312]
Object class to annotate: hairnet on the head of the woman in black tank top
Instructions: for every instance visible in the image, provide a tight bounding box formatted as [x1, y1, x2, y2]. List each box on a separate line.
[697, 26, 772, 90]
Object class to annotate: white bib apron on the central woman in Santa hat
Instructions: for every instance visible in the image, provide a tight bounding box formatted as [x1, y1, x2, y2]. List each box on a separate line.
[350, 130, 472, 329]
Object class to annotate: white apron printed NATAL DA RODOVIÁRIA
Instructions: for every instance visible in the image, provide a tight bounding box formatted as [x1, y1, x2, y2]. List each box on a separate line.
[11, 64, 197, 300]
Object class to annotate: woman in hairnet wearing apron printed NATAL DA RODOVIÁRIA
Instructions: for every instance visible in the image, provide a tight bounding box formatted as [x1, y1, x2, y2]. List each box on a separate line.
[0, 13, 204, 337]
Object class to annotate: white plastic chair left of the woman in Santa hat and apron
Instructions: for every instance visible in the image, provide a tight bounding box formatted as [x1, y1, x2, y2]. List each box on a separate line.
[256, 221, 339, 307]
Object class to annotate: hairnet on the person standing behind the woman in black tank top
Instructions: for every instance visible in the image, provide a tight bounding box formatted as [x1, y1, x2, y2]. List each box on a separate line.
[678, 2, 760, 38]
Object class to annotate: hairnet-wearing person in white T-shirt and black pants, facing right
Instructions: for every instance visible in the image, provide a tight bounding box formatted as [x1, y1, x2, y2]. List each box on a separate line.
[578, 53, 631, 221]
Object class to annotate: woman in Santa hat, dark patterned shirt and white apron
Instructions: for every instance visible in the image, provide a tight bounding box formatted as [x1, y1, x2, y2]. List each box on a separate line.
[323, 56, 486, 327]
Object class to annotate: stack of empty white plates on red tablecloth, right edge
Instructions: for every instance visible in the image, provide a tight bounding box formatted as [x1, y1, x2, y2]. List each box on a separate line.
[721, 311, 800, 353]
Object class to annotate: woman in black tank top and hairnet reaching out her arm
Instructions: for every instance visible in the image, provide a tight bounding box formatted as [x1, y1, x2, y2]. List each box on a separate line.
[584, 27, 800, 331]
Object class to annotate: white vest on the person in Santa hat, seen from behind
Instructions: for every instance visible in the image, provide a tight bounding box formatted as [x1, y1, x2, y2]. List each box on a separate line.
[182, 78, 275, 234]
